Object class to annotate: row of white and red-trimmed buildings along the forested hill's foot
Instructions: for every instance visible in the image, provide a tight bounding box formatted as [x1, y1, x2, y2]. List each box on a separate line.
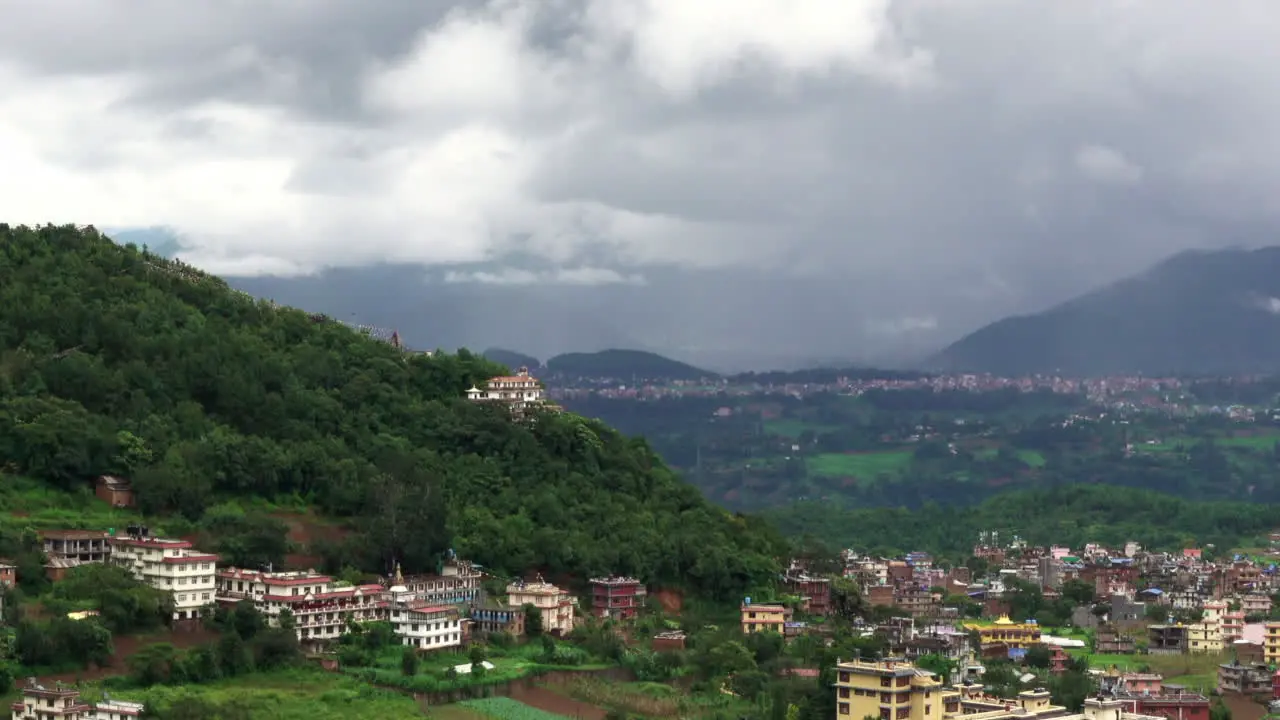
[28, 517, 646, 651]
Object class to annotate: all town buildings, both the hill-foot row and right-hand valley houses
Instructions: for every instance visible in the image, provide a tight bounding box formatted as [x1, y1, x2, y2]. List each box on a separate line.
[20, 509, 1280, 720]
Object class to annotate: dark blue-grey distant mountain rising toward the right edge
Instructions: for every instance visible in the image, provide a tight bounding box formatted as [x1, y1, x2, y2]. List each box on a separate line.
[928, 247, 1280, 375]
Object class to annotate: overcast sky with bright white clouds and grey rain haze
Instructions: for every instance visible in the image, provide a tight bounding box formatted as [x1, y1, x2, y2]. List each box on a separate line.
[0, 0, 1280, 364]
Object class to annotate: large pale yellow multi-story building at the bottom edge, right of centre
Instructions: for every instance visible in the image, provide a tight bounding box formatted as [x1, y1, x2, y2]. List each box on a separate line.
[836, 660, 960, 720]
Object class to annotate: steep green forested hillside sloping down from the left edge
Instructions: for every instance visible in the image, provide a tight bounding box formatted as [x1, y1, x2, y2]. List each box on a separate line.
[0, 224, 778, 597]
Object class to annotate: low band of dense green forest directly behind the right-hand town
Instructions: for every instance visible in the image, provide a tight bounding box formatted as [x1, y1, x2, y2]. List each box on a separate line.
[764, 484, 1280, 561]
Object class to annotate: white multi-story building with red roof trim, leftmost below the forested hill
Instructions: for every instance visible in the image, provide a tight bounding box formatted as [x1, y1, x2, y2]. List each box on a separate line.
[109, 536, 218, 620]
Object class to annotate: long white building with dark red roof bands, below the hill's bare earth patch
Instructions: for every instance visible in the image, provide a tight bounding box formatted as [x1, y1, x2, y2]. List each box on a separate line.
[218, 568, 387, 646]
